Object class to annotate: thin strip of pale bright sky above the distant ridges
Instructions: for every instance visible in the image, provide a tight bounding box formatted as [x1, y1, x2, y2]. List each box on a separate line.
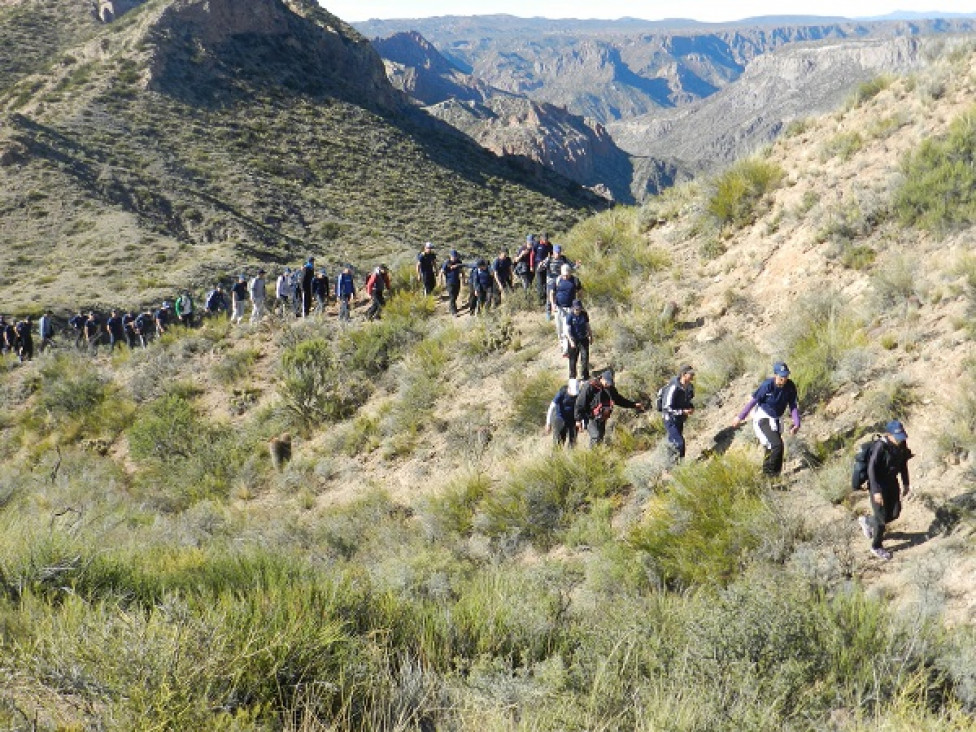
[319, 0, 976, 22]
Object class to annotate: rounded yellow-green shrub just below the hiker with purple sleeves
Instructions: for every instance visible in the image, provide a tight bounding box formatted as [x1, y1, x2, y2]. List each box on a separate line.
[630, 452, 770, 587]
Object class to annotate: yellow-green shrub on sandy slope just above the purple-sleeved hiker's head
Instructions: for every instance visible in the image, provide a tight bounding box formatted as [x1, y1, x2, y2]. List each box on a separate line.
[779, 293, 867, 404]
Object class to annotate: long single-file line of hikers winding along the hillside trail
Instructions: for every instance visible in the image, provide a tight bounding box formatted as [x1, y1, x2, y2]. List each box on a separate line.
[0, 234, 912, 559]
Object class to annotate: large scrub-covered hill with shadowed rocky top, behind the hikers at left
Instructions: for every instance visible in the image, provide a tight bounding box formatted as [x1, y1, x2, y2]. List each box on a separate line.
[0, 0, 605, 308]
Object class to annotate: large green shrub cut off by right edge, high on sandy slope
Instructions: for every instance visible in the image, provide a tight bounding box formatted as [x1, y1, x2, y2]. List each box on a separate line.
[894, 109, 976, 232]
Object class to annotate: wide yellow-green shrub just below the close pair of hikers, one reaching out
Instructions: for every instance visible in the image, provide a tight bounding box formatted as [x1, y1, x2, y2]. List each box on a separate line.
[475, 450, 625, 548]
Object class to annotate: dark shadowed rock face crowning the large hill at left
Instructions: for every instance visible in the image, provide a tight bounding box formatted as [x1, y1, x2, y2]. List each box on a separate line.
[150, 0, 401, 111]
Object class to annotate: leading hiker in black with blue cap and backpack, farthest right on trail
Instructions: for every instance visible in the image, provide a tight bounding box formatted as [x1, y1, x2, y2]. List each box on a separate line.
[857, 419, 912, 560]
